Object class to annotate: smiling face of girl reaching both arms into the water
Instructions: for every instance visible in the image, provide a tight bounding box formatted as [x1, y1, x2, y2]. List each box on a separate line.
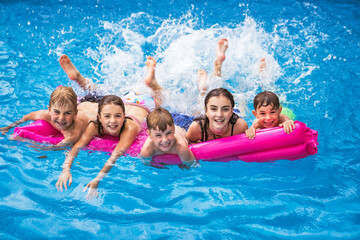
[98, 104, 125, 137]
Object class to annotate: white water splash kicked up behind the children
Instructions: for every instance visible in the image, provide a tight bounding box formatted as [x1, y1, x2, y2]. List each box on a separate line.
[77, 7, 318, 115]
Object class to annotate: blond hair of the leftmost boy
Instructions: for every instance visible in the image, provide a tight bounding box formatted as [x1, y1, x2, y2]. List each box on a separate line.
[49, 86, 77, 111]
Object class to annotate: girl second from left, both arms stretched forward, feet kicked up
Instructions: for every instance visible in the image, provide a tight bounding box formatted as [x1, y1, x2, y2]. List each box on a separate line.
[56, 55, 161, 199]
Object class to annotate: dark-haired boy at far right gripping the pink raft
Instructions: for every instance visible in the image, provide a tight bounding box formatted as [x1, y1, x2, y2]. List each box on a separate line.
[245, 91, 295, 139]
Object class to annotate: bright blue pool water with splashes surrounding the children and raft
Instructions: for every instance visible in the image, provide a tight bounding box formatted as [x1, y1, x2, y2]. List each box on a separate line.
[0, 0, 360, 239]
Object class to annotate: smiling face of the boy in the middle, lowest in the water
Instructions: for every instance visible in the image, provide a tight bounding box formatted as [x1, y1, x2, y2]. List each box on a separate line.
[149, 125, 175, 152]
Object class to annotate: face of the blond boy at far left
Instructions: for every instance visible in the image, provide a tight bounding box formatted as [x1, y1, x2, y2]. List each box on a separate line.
[49, 103, 77, 131]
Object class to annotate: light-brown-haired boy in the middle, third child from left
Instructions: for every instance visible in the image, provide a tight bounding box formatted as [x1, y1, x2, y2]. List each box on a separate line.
[140, 107, 194, 162]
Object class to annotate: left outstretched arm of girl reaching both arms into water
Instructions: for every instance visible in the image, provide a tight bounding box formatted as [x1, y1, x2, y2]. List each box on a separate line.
[56, 123, 98, 191]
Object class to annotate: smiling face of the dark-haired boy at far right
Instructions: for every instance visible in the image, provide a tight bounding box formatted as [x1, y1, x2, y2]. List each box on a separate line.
[253, 104, 282, 128]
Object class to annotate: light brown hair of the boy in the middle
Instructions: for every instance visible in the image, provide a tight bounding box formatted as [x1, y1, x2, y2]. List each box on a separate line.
[146, 107, 174, 132]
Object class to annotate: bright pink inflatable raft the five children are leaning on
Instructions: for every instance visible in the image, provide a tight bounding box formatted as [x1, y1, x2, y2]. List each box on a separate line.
[14, 120, 318, 166]
